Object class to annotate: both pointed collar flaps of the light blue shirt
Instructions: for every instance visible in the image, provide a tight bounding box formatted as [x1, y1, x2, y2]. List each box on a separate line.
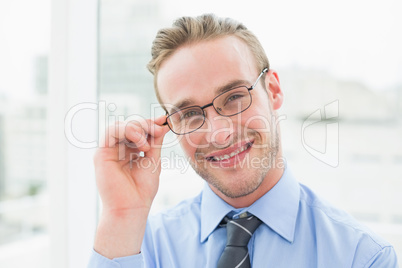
[200, 168, 300, 243]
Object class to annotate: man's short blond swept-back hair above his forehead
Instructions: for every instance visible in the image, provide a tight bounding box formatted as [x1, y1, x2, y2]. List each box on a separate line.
[147, 14, 269, 103]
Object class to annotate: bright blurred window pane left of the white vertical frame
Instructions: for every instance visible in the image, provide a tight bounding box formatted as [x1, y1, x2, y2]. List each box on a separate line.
[0, 0, 50, 267]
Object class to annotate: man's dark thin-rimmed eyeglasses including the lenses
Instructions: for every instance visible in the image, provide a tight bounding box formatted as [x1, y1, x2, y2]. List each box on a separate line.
[163, 68, 268, 135]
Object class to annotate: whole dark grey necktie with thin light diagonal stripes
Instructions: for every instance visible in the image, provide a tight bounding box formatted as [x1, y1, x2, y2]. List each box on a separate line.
[217, 216, 261, 268]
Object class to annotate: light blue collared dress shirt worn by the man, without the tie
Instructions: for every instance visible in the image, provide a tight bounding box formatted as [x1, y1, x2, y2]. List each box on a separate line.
[88, 169, 398, 268]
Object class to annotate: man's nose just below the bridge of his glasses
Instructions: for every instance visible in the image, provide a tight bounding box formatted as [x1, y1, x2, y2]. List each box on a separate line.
[204, 107, 234, 148]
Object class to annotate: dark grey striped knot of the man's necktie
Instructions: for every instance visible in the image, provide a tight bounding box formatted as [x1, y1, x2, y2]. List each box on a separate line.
[226, 216, 261, 247]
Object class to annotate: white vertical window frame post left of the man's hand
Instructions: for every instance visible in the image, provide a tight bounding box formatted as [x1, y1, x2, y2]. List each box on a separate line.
[47, 0, 99, 268]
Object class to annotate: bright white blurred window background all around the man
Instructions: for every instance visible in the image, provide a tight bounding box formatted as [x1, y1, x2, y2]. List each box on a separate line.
[0, 0, 402, 268]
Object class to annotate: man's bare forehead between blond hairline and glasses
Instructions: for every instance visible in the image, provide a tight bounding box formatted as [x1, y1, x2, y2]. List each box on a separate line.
[157, 36, 257, 109]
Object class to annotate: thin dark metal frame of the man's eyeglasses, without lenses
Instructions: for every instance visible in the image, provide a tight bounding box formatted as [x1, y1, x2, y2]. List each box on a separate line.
[162, 67, 269, 135]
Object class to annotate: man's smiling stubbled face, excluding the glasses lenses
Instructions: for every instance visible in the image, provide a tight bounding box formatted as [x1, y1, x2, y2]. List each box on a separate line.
[157, 36, 280, 198]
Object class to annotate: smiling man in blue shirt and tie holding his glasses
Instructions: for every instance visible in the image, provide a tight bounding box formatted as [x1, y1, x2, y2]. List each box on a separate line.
[89, 15, 397, 268]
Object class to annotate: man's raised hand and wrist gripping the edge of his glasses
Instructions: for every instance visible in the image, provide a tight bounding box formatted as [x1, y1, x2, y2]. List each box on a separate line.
[94, 116, 169, 258]
